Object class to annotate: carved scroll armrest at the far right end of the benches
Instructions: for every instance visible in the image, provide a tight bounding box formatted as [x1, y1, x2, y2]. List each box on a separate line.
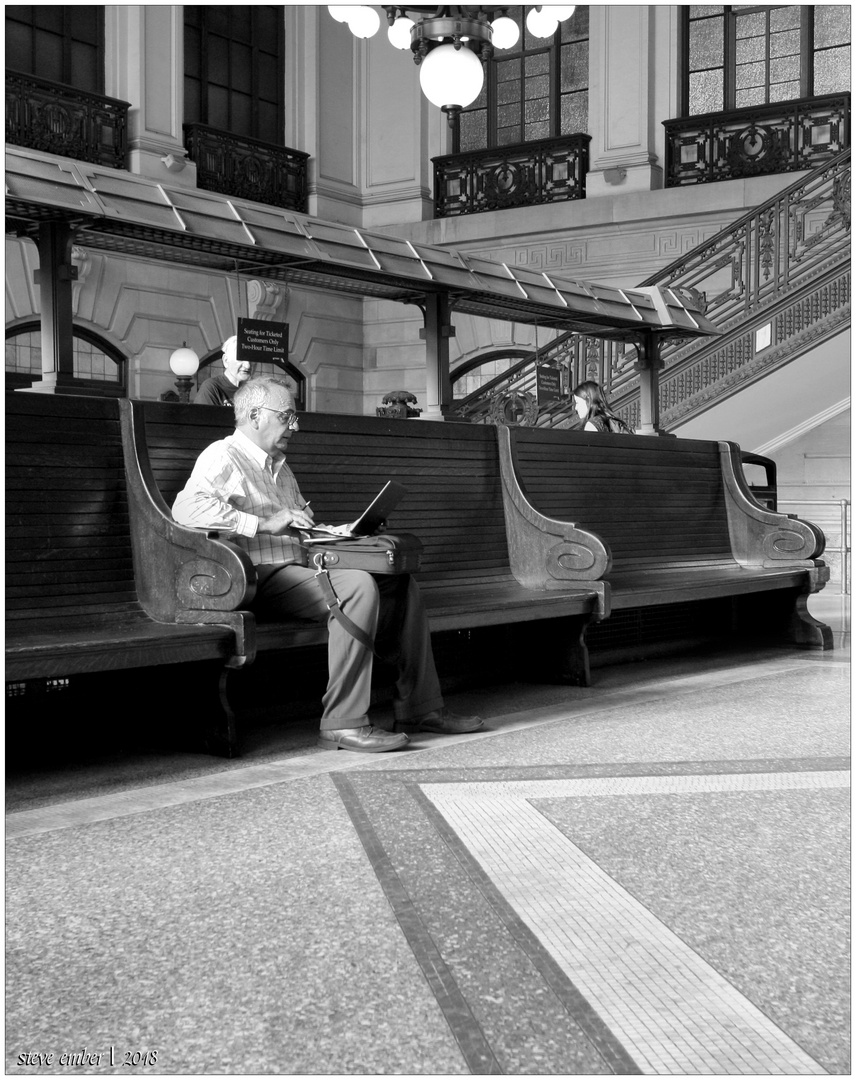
[719, 442, 826, 569]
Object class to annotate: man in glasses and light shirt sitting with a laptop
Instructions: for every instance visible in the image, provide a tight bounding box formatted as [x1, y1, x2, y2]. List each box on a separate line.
[173, 376, 481, 754]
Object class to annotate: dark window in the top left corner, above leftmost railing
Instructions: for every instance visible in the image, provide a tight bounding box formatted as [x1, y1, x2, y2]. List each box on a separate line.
[5, 4, 104, 94]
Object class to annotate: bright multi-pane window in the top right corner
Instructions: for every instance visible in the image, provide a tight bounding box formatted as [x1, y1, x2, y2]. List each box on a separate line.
[682, 4, 851, 116]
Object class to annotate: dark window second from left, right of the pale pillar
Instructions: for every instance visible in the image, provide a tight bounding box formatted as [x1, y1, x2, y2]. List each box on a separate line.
[185, 4, 285, 145]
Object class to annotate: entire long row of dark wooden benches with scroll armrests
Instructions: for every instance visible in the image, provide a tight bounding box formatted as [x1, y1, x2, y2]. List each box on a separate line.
[5, 393, 831, 755]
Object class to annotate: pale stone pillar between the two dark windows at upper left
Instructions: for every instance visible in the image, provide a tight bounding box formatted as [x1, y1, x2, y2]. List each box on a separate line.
[105, 4, 196, 187]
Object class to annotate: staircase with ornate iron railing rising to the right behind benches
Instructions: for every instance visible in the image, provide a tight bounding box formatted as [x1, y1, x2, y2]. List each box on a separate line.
[454, 149, 851, 430]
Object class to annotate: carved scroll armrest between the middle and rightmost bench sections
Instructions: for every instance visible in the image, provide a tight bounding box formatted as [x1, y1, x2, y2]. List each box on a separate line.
[497, 427, 612, 590]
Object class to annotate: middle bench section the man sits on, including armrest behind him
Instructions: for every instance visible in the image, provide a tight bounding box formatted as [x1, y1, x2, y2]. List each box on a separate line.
[120, 401, 603, 754]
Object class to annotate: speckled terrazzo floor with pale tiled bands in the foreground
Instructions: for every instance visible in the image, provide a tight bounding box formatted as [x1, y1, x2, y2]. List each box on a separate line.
[6, 613, 848, 1076]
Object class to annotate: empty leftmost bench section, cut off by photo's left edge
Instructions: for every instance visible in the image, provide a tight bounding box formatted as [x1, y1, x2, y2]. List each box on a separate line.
[5, 393, 240, 683]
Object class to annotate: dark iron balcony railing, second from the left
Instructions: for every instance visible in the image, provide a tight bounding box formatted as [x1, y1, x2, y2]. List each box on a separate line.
[185, 124, 309, 214]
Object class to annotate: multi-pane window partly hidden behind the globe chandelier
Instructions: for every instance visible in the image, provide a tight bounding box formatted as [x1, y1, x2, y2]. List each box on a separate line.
[454, 6, 588, 153]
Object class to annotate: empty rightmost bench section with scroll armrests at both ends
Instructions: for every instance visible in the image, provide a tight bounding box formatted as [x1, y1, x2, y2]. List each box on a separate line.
[499, 428, 832, 649]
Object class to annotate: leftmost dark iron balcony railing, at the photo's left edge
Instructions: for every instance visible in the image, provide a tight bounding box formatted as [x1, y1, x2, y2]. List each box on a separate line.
[6, 71, 131, 168]
